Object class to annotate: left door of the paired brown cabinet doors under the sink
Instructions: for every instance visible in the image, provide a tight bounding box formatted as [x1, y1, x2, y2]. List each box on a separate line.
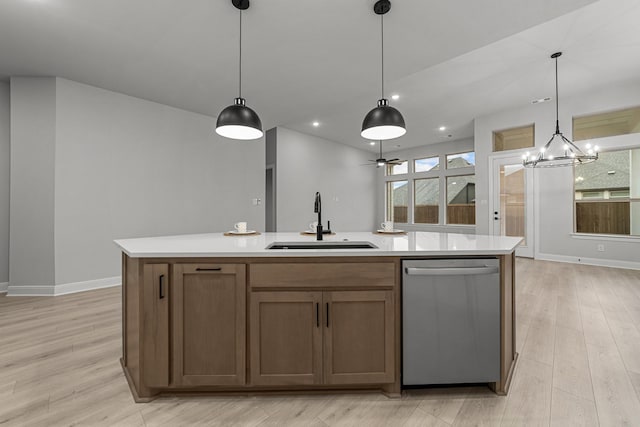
[249, 292, 322, 385]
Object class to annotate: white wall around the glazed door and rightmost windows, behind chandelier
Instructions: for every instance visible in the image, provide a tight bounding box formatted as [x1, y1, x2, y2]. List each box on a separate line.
[475, 83, 640, 268]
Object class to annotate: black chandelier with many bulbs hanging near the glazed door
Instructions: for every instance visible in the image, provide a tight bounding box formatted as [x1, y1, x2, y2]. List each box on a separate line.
[522, 52, 598, 168]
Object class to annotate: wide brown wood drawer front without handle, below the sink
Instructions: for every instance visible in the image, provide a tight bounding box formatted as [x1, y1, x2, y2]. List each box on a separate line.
[249, 262, 396, 288]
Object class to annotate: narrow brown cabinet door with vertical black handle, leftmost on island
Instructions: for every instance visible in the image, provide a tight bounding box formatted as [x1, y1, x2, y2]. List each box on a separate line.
[140, 264, 170, 387]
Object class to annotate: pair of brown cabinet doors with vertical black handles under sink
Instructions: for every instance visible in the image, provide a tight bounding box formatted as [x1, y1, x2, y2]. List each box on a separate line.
[250, 290, 395, 386]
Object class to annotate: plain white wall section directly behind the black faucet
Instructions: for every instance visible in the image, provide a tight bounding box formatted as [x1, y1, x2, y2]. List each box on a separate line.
[276, 127, 376, 231]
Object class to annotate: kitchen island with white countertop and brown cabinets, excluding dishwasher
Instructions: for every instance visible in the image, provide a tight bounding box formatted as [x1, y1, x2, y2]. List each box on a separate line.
[116, 232, 520, 402]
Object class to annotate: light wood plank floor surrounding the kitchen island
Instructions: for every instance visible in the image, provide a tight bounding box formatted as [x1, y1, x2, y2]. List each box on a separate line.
[0, 259, 640, 427]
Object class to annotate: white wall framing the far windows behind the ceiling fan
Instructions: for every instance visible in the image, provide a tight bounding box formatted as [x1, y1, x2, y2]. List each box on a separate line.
[374, 138, 477, 233]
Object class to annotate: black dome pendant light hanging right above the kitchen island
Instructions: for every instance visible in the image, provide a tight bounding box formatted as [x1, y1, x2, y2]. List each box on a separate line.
[360, 0, 407, 140]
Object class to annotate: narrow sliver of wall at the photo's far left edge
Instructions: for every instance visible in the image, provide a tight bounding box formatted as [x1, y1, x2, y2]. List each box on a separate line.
[0, 82, 11, 292]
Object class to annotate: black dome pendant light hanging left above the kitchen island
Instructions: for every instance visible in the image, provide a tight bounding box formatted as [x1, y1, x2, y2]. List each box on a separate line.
[216, 0, 264, 139]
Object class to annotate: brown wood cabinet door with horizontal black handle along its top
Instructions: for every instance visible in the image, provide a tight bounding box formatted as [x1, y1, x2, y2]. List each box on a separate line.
[172, 264, 246, 386]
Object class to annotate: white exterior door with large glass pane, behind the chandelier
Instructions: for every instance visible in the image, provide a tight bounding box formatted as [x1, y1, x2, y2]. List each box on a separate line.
[490, 157, 534, 258]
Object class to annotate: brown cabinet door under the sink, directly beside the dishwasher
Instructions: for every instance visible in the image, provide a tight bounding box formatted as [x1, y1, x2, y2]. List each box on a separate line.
[324, 291, 395, 384]
